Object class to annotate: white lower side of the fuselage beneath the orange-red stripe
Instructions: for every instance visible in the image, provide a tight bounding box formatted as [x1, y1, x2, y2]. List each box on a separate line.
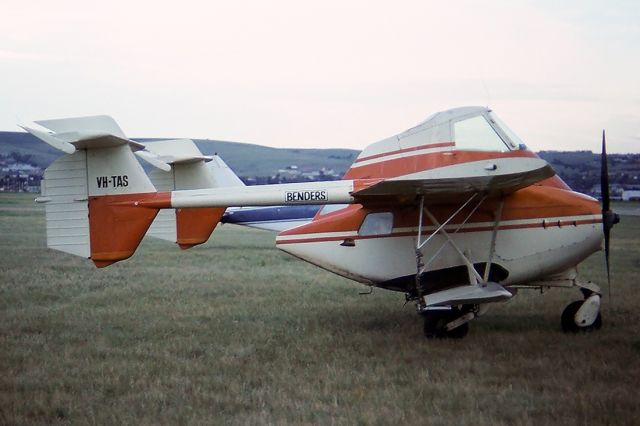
[276, 216, 602, 285]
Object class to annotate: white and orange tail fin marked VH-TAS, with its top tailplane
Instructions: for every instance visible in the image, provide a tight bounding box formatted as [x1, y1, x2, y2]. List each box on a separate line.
[25, 116, 162, 267]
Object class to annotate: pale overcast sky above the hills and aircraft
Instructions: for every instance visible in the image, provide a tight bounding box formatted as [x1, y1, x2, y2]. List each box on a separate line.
[0, 0, 640, 153]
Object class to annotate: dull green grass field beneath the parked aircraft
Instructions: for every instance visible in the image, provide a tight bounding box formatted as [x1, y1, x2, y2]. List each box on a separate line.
[0, 194, 640, 425]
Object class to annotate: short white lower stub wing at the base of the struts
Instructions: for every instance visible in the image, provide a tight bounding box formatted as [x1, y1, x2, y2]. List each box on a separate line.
[424, 283, 512, 306]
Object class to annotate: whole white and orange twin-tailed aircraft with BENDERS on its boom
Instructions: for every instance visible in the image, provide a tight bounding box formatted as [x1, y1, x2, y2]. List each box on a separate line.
[24, 107, 618, 338]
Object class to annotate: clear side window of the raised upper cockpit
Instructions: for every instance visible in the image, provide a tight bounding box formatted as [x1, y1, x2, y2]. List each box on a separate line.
[453, 115, 509, 152]
